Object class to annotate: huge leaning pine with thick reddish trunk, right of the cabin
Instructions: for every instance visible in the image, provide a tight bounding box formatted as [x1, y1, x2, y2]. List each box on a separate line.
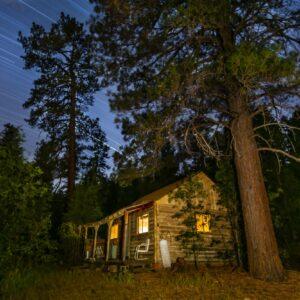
[91, 0, 299, 280]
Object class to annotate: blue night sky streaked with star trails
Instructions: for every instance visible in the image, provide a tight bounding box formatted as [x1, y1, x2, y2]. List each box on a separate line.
[0, 0, 123, 159]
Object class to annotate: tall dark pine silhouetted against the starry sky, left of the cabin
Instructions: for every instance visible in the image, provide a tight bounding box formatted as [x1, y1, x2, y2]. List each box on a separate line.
[19, 13, 107, 206]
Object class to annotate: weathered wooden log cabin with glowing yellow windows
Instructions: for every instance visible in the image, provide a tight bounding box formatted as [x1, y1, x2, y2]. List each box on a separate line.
[82, 172, 234, 266]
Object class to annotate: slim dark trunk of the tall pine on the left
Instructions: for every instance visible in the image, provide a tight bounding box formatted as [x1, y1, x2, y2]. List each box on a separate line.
[67, 88, 76, 206]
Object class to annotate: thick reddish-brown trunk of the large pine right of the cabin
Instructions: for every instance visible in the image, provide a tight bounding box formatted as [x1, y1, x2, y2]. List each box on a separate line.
[230, 99, 284, 281]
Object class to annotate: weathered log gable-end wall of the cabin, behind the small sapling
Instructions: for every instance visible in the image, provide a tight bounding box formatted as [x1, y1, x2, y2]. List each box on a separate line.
[156, 177, 234, 265]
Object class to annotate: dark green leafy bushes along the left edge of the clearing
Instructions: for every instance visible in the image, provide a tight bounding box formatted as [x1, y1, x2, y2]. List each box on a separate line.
[0, 124, 55, 278]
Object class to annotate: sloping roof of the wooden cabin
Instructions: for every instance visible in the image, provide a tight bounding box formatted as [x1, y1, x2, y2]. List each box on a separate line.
[84, 172, 214, 227]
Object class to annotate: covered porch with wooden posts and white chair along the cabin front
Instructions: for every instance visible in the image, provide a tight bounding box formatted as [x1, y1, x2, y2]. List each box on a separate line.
[81, 202, 154, 264]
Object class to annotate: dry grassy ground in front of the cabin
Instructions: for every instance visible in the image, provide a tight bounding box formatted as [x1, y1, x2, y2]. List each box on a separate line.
[4, 269, 300, 300]
